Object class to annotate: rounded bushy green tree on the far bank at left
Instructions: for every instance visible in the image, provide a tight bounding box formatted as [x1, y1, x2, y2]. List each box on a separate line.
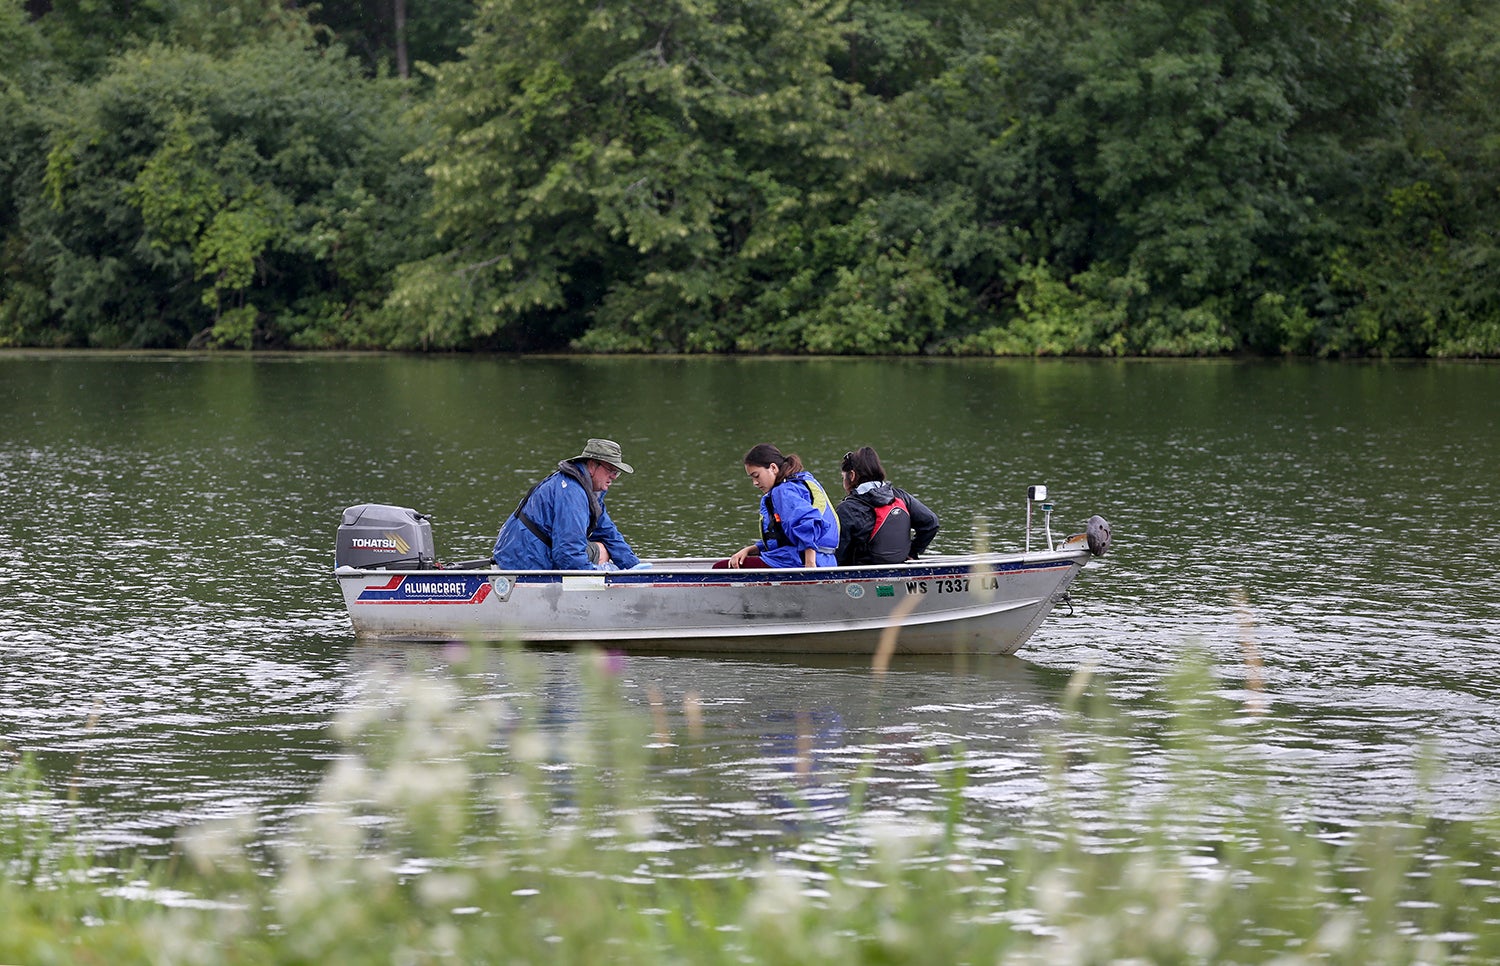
[20, 42, 426, 347]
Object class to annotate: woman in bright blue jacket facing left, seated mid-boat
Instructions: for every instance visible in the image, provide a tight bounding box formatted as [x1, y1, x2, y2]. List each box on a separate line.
[714, 443, 839, 569]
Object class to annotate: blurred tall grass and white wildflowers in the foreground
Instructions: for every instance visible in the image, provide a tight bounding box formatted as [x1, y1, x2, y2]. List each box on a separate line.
[0, 653, 1500, 966]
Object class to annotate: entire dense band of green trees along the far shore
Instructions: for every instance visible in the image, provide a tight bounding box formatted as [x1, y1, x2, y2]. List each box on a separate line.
[0, 0, 1500, 357]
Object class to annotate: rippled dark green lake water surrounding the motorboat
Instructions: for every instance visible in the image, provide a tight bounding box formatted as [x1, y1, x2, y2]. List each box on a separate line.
[0, 354, 1500, 857]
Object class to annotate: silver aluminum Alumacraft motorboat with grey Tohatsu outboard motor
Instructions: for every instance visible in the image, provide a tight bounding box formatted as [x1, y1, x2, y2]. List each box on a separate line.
[335, 488, 1110, 654]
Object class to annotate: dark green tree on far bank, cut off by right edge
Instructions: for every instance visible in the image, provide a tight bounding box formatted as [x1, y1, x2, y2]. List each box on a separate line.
[1320, 0, 1500, 356]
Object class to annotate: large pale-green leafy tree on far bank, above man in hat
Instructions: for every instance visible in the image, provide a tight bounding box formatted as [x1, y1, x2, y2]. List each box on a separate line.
[389, 0, 884, 351]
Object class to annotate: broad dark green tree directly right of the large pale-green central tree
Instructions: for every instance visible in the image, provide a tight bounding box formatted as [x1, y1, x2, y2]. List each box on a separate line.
[881, 0, 1400, 354]
